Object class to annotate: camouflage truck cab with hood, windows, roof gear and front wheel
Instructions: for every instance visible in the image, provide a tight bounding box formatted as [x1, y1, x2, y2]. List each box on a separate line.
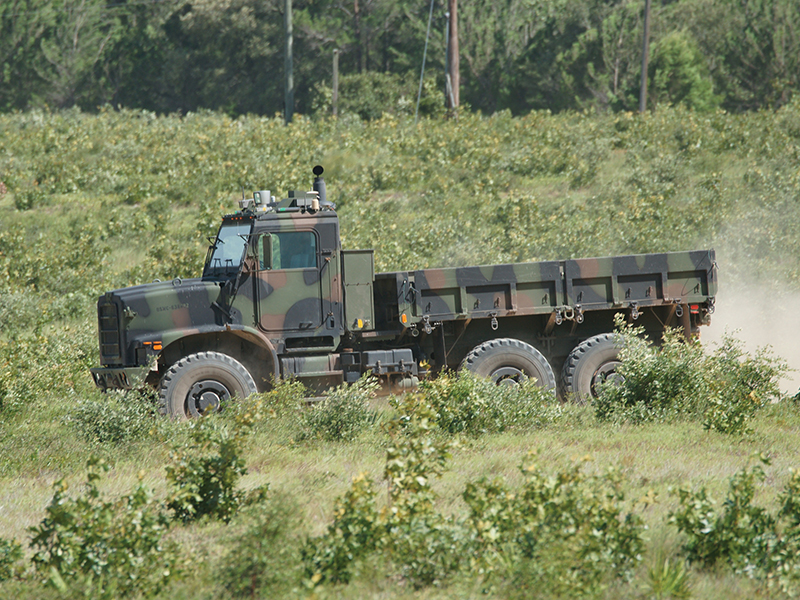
[92, 167, 417, 417]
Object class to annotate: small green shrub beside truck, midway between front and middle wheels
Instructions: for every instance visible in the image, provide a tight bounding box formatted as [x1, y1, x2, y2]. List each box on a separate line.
[297, 376, 378, 442]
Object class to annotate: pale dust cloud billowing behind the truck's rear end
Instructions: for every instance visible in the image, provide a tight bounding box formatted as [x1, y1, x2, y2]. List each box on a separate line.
[700, 278, 800, 395]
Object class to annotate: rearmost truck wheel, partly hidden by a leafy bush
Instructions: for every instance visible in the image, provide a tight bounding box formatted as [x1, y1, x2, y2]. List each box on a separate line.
[561, 333, 622, 404]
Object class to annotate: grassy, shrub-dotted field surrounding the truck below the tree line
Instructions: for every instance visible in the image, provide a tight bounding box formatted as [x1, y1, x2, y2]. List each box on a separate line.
[0, 103, 800, 598]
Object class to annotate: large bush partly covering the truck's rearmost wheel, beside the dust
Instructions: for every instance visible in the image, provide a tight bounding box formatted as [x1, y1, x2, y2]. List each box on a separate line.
[595, 316, 787, 433]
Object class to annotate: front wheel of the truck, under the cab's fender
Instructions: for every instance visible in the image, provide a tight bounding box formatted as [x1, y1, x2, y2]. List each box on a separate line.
[159, 352, 258, 419]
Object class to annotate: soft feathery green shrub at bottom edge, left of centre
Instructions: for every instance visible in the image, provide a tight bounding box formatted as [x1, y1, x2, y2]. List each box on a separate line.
[220, 495, 302, 598]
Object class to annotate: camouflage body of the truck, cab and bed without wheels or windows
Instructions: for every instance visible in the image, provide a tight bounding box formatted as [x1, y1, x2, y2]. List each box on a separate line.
[92, 191, 717, 389]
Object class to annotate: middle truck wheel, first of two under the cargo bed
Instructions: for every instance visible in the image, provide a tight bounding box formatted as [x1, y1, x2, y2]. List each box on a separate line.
[461, 338, 556, 390]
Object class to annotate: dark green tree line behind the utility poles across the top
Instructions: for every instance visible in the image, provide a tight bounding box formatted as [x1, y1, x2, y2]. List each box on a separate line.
[0, 0, 800, 118]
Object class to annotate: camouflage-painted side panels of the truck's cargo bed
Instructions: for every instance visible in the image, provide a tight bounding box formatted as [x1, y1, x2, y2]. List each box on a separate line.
[401, 250, 717, 326]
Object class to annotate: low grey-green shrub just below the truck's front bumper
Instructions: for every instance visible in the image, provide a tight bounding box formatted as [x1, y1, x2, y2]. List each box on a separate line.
[67, 393, 154, 445]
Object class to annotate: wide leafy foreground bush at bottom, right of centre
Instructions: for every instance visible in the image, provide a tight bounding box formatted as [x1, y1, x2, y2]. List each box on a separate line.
[464, 454, 644, 597]
